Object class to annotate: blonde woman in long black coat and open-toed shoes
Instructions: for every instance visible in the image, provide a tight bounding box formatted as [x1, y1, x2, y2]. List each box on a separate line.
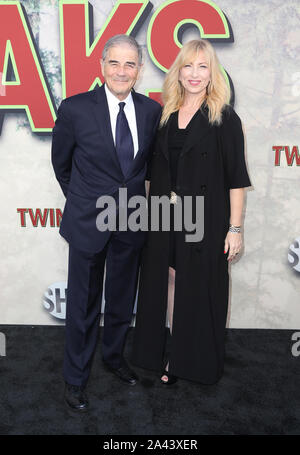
[132, 40, 251, 385]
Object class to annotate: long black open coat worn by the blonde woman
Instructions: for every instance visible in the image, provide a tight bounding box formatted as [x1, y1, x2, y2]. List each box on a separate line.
[132, 107, 251, 384]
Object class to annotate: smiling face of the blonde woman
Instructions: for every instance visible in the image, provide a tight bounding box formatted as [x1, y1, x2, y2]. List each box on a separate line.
[179, 51, 210, 96]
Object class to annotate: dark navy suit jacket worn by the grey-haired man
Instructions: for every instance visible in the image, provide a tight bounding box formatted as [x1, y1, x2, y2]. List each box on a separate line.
[52, 86, 161, 253]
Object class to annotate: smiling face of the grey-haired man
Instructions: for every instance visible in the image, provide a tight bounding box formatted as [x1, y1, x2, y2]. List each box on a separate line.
[101, 43, 140, 101]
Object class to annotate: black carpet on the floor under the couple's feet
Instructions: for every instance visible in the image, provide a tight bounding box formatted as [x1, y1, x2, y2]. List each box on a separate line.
[0, 325, 300, 435]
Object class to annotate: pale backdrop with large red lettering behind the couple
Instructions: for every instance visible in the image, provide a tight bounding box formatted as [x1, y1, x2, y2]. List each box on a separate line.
[0, 0, 300, 329]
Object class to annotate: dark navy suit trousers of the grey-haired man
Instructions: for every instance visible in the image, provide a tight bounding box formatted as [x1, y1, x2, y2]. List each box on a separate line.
[63, 232, 141, 387]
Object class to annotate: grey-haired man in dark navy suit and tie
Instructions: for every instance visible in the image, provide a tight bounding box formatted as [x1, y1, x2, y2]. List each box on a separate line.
[52, 35, 161, 411]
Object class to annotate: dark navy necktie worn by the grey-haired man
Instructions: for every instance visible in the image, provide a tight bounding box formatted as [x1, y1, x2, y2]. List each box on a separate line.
[116, 102, 134, 176]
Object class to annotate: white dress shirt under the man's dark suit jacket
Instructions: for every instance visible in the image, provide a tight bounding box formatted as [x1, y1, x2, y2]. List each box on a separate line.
[104, 84, 139, 157]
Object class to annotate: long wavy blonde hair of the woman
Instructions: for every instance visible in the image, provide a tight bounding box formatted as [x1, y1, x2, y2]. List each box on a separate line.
[160, 39, 230, 126]
